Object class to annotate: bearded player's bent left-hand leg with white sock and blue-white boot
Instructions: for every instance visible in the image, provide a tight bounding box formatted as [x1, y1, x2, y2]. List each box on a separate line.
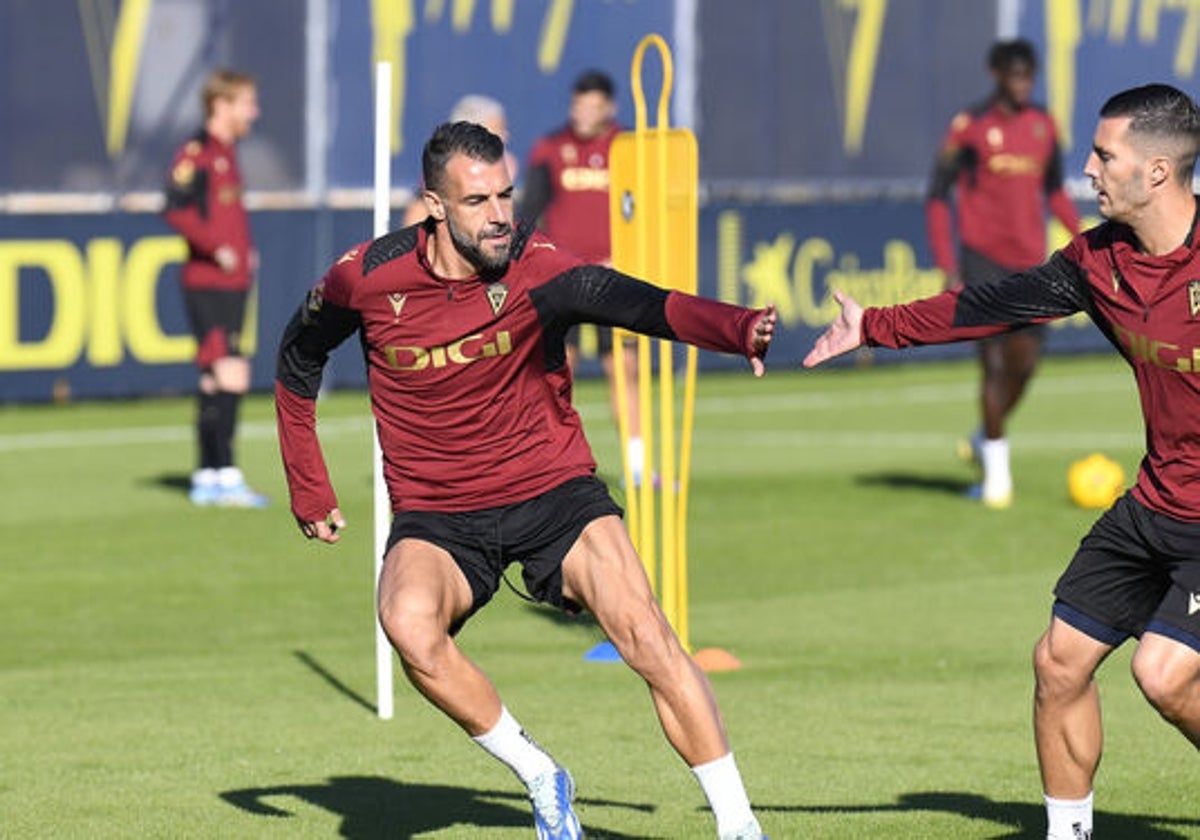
[379, 540, 582, 840]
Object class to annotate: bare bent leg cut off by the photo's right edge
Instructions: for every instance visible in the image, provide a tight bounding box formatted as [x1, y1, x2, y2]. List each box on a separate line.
[1133, 632, 1200, 749]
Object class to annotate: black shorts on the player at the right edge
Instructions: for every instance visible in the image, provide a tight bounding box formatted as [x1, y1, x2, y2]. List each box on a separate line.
[1054, 493, 1200, 652]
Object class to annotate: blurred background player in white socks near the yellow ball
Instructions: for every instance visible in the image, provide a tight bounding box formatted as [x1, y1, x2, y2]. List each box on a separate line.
[925, 40, 1079, 508]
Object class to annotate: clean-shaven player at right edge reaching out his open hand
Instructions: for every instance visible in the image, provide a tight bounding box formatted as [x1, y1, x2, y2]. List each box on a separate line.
[804, 84, 1200, 840]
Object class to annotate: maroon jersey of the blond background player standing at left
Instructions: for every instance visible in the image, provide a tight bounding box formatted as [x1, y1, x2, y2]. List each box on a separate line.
[163, 131, 253, 292]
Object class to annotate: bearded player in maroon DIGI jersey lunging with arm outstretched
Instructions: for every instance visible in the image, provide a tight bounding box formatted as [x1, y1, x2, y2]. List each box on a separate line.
[275, 122, 775, 839]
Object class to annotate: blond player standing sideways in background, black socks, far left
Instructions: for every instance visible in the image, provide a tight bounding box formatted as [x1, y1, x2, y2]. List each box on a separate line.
[163, 70, 266, 508]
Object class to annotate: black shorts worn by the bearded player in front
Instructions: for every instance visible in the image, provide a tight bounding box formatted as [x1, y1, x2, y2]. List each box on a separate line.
[388, 475, 624, 632]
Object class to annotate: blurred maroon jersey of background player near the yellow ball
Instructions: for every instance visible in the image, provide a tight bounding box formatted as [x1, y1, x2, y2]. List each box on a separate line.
[925, 100, 1079, 274]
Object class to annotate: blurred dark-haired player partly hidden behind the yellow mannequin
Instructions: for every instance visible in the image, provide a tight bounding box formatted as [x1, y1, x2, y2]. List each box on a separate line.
[516, 70, 646, 484]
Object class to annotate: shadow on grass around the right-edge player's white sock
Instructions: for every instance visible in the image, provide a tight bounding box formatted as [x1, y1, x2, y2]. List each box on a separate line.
[755, 792, 1200, 840]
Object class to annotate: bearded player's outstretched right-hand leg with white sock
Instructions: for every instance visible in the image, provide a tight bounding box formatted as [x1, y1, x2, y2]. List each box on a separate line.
[563, 516, 762, 839]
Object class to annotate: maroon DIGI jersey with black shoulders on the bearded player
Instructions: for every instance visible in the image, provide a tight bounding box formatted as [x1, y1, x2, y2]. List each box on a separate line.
[276, 224, 758, 522]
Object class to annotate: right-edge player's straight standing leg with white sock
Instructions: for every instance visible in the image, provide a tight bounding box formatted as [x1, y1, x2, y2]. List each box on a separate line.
[1033, 617, 1112, 838]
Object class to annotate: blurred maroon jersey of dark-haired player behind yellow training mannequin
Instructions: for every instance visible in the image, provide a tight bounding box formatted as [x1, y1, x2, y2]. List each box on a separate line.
[518, 125, 620, 263]
